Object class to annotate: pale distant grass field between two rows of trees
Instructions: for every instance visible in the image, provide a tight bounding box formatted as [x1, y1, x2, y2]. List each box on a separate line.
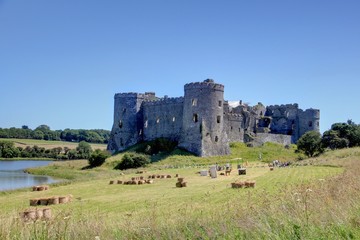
[0, 138, 106, 150]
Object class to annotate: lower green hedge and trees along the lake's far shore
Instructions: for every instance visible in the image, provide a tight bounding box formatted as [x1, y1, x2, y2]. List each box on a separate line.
[0, 141, 92, 160]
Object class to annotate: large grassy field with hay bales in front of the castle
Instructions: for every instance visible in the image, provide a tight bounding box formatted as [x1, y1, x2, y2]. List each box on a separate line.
[0, 145, 360, 239]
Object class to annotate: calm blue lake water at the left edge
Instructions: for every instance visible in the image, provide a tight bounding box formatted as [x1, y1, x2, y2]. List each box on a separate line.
[0, 161, 56, 191]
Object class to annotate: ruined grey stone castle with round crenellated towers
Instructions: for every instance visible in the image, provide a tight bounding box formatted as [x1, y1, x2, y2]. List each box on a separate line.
[108, 79, 320, 156]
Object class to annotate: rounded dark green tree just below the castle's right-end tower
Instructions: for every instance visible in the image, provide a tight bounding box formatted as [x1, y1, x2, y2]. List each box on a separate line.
[297, 131, 324, 157]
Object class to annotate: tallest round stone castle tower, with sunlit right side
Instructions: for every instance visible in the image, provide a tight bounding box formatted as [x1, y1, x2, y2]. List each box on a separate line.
[179, 79, 230, 156]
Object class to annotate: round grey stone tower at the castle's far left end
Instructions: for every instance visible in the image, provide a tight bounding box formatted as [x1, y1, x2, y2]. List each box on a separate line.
[108, 93, 145, 152]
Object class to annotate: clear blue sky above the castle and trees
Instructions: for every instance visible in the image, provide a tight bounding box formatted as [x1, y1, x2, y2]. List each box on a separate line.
[0, 0, 360, 132]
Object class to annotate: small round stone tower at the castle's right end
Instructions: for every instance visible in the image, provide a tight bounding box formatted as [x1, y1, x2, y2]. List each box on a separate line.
[295, 108, 320, 142]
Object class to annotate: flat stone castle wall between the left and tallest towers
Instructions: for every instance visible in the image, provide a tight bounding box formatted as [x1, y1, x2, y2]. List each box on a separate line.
[142, 98, 184, 141]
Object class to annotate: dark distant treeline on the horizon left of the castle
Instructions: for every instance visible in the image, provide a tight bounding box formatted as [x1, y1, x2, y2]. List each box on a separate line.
[0, 125, 110, 143]
